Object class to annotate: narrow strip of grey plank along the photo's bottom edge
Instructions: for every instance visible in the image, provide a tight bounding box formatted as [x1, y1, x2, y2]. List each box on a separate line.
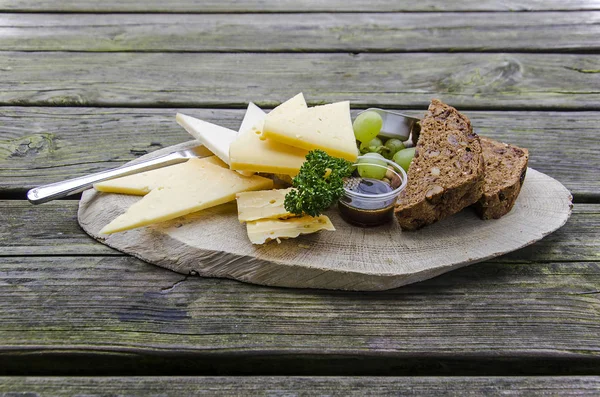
[0, 376, 600, 397]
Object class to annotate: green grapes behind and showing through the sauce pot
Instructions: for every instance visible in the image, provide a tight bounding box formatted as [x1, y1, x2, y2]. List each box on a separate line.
[352, 111, 415, 175]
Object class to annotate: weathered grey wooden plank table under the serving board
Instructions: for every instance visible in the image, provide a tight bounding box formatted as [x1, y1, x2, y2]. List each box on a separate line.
[0, 0, 600, 395]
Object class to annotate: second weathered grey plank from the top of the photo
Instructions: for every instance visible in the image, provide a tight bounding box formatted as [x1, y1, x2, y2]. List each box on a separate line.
[0, 11, 600, 52]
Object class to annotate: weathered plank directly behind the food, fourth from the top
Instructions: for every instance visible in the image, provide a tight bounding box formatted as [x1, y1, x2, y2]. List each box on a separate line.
[0, 107, 600, 202]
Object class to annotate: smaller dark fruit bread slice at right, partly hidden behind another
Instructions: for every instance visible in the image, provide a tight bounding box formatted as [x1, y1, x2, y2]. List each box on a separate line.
[473, 137, 529, 219]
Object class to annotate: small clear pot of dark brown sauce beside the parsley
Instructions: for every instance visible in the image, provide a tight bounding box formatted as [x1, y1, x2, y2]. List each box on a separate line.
[338, 156, 407, 227]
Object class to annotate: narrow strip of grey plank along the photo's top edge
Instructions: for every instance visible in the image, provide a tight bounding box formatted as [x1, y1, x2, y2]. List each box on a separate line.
[0, 0, 600, 13]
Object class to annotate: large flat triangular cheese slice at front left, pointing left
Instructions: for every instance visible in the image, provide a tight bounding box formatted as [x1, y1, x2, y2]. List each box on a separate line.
[100, 159, 273, 234]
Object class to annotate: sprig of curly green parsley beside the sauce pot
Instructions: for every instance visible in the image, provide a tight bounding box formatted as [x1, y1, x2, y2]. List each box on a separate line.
[283, 150, 352, 216]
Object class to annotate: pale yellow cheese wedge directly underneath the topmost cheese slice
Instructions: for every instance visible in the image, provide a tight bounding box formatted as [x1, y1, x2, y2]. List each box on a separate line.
[229, 93, 308, 175]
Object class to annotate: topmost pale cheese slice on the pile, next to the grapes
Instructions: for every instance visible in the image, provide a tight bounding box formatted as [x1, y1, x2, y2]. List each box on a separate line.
[263, 101, 358, 161]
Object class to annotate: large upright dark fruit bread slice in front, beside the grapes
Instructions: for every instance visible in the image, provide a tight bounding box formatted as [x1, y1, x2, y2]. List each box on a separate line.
[395, 99, 485, 230]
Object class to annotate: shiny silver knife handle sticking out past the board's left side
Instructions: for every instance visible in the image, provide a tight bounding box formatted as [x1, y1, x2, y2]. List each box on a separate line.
[27, 152, 187, 204]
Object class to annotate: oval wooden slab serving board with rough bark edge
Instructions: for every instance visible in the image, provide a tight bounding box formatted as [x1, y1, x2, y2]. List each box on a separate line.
[78, 142, 572, 291]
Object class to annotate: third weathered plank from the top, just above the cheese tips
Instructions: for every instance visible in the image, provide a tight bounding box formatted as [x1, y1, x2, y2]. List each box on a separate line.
[0, 52, 600, 110]
